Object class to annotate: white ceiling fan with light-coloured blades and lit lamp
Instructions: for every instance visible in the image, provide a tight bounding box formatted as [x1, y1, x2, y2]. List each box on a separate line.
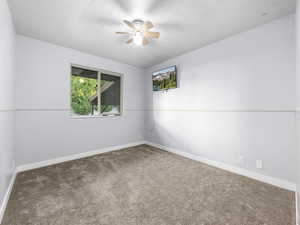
[116, 19, 160, 45]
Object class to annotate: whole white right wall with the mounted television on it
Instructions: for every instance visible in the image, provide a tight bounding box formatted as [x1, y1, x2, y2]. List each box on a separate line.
[145, 15, 296, 182]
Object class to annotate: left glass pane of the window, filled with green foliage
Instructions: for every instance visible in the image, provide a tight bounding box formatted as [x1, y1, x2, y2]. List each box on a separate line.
[71, 67, 98, 116]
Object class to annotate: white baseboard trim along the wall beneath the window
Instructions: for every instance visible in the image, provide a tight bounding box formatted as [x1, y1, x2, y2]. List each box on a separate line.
[16, 141, 145, 172]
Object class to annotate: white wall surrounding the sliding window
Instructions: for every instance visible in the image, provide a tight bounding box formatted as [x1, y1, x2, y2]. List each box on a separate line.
[16, 35, 144, 165]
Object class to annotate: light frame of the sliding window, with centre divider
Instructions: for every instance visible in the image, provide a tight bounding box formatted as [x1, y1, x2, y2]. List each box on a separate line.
[69, 63, 124, 119]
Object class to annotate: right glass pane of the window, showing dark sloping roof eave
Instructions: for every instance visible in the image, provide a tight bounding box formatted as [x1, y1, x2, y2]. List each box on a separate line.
[100, 74, 121, 115]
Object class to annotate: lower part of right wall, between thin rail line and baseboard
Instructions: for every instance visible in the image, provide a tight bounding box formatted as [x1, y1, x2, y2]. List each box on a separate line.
[146, 108, 295, 181]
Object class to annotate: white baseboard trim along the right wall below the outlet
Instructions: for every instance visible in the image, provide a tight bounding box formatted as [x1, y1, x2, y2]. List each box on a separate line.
[146, 141, 296, 191]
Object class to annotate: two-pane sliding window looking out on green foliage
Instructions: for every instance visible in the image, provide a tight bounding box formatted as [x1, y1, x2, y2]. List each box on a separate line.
[71, 66, 122, 116]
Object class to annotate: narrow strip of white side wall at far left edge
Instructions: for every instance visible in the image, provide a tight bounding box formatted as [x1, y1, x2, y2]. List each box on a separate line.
[0, 0, 15, 209]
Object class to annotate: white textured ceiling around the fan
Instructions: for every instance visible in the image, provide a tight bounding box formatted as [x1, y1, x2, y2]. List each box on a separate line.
[8, 0, 296, 67]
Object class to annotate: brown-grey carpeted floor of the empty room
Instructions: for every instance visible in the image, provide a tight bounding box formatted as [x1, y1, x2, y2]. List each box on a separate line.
[2, 145, 295, 225]
